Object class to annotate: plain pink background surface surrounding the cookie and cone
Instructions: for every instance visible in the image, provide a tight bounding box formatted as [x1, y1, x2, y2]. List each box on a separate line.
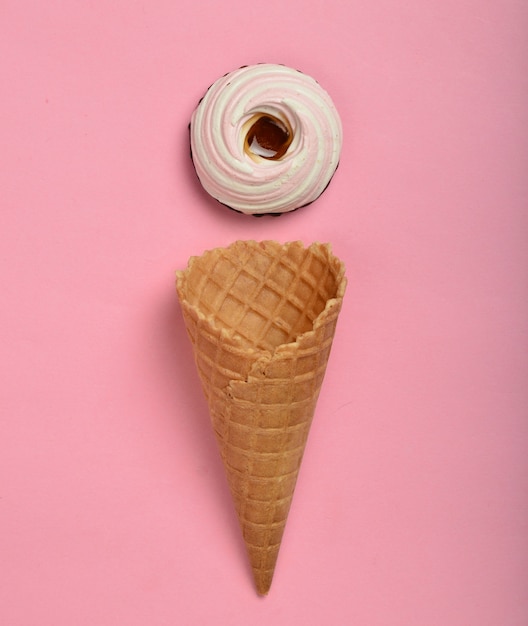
[0, 0, 528, 626]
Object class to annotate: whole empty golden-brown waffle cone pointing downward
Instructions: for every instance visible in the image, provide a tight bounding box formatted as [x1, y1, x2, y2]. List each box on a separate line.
[176, 241, 346, 594]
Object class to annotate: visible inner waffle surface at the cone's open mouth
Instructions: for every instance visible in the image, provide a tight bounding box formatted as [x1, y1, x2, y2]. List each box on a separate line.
[182, 242, 336, 350]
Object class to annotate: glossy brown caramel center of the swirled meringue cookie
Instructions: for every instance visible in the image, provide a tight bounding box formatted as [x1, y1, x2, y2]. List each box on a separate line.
[244, 113, 293, 161]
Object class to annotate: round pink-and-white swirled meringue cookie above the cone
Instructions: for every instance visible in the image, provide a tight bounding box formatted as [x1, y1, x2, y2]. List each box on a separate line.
[190, 63, 342, 215]
